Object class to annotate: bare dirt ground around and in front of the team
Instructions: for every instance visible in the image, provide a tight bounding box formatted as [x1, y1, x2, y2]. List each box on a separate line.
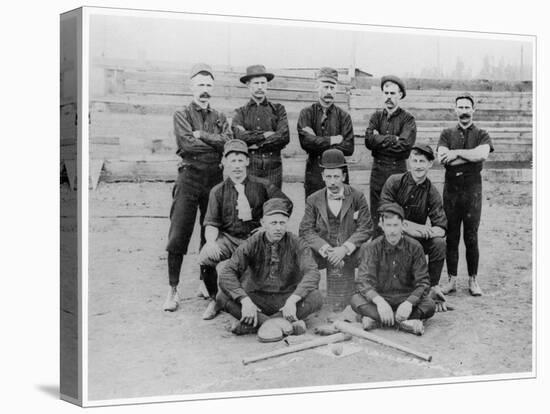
[82, 178, 533, 400]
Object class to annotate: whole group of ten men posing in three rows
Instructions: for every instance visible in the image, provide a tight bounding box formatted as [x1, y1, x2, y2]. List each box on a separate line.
[163, 64, 493, 337]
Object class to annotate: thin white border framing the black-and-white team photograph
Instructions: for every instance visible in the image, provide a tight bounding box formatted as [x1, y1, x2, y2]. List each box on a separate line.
[79, 7, 538, 409]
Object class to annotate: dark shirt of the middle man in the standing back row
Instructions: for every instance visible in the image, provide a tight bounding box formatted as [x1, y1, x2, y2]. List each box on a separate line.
[298, 102, 355, 156]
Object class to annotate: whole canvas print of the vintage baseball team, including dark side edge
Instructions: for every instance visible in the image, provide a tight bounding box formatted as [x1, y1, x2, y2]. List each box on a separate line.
[59, 2, 537, 406]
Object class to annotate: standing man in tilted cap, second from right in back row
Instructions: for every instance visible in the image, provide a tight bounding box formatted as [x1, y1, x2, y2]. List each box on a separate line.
[365, 75, 416, 231]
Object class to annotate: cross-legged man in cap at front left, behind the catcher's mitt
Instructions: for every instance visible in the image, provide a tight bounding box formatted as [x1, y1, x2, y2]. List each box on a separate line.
[216, 198, 323, 340]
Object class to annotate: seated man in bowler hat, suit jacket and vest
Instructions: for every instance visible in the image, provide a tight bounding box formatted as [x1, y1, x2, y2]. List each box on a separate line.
[300, 149, 373, 269]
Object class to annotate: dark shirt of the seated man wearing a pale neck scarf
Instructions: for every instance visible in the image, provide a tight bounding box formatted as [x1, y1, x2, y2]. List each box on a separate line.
[204, 176, 292, 239]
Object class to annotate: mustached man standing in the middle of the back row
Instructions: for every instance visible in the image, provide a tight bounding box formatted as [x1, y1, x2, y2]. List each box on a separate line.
[298, 67, 354, 198]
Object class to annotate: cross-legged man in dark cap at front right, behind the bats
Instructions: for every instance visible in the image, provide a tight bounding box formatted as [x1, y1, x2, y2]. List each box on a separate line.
[351, 203, 435, 335]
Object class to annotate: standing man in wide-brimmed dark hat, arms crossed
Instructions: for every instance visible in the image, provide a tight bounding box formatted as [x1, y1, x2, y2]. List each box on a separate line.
[231, 65, 290, 189]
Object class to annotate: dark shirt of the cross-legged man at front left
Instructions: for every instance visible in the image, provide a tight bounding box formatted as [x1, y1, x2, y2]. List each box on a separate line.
[219, 232, 320, 300]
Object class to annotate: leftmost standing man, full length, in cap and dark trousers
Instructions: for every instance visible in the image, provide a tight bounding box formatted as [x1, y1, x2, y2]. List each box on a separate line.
[163, 63, 231, 311]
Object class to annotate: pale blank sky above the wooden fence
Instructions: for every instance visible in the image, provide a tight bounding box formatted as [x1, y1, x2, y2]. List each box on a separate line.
[90, 13, 534, 76]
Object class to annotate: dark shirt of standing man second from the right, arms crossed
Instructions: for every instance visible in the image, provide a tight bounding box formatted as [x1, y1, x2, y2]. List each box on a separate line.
[365, 107, 416, 161]
